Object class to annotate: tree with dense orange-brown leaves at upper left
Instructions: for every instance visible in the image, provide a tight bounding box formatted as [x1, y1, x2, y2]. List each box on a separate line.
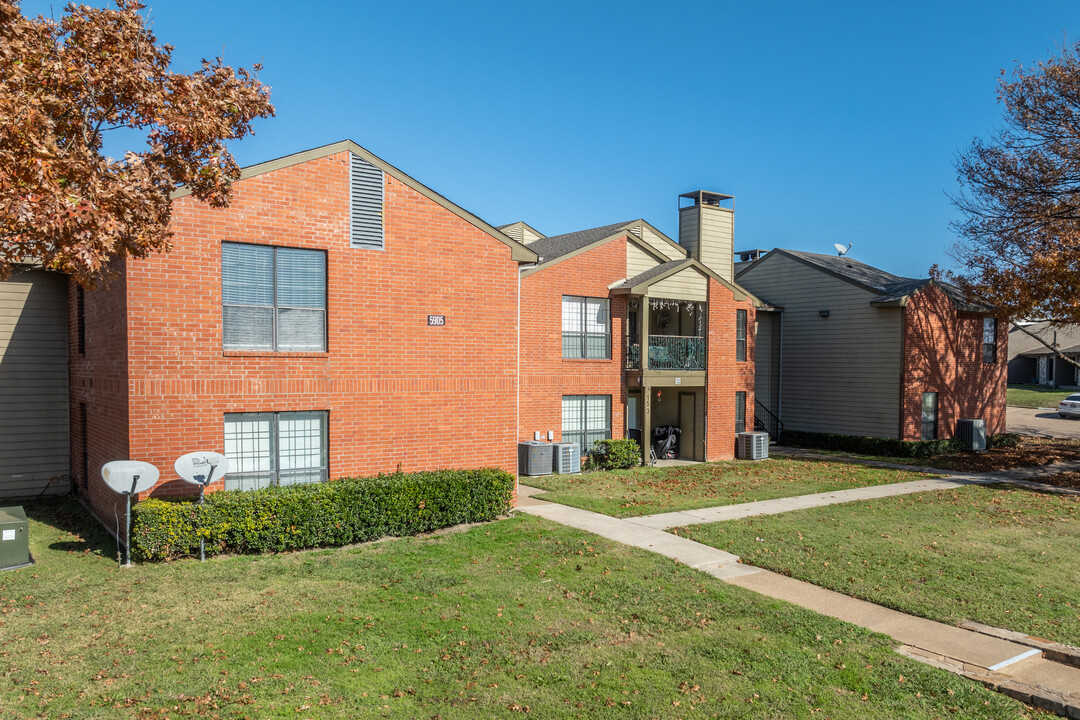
[0, 0, 274, 285]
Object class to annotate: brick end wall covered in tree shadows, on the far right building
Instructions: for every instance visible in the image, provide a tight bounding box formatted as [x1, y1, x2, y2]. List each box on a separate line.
[901, 285, 1009, 440]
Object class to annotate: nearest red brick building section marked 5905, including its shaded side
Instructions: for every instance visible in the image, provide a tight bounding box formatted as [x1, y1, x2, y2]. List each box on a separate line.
[69, 141, 536, 518]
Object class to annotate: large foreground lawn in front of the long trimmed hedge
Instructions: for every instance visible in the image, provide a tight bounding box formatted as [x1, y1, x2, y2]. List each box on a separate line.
[0, 502, 1029, 720]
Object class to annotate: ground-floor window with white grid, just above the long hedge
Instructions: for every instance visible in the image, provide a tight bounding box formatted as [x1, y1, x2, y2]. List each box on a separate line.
[225, 411, 329, 490]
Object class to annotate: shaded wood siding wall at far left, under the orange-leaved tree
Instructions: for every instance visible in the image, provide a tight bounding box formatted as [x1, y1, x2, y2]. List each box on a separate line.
[0, 270, 70, 501]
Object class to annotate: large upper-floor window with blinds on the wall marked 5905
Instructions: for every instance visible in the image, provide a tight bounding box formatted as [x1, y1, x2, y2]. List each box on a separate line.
[221, 243, 326, 352]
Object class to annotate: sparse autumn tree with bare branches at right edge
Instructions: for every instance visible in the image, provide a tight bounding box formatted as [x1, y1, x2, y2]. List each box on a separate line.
[951, 43, 1080, 365]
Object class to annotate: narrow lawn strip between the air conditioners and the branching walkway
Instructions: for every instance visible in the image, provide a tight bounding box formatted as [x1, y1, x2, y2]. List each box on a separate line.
[522, 458, 934, 517]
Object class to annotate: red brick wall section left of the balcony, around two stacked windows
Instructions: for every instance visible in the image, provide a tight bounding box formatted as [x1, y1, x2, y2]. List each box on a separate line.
[518, 237, 626, 441]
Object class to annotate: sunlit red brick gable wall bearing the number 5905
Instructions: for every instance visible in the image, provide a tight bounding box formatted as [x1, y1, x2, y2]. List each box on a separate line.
[72, 152, 517, 520]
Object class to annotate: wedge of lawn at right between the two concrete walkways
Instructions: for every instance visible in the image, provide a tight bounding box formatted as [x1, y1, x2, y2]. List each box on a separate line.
[678, 486, 1080, 644]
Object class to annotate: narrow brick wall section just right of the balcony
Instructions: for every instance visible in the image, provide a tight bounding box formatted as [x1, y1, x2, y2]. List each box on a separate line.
[705, 277, 754, 461]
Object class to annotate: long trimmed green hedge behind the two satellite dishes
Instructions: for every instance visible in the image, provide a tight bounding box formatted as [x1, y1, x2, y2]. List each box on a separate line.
[132, 468, 514, 561]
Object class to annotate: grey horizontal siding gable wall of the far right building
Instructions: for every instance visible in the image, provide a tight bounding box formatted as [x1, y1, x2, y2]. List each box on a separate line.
[739, 254, 903, 437]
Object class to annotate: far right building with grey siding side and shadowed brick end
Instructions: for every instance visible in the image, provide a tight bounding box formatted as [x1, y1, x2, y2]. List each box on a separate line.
[737, 249, 1008, 440]
